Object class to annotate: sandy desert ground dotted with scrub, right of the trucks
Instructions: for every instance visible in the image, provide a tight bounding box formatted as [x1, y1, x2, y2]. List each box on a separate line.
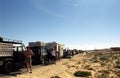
[0, 51, 120, 78]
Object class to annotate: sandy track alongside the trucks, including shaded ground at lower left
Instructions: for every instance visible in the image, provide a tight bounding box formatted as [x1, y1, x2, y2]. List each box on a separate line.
[0, 59, 71, 78]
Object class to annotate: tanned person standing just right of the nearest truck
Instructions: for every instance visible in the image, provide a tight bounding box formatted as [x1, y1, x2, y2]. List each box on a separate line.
[24, 47, 34, 73]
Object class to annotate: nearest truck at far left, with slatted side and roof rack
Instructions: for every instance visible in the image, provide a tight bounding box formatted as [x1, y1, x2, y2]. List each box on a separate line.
[0, 37, 25, 73]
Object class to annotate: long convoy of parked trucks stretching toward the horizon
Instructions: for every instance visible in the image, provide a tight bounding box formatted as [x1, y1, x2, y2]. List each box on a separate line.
[0, 37, 83, 73]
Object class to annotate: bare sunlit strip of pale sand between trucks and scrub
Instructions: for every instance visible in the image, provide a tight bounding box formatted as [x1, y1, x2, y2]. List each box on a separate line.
[10, 59, 73, 78]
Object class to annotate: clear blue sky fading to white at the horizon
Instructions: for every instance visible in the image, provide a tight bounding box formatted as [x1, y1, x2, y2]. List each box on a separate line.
[0, 0, 120, 49]
